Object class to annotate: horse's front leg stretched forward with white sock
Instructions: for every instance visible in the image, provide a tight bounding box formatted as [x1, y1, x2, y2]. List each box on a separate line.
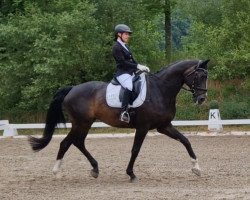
[157, 124, 201, 176]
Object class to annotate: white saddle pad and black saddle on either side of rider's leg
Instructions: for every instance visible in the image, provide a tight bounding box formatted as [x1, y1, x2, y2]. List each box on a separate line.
[106, 73, 147, 108]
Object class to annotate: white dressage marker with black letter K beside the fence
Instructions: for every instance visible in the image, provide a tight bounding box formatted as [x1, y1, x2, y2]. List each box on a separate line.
[208, 109, 223, 132]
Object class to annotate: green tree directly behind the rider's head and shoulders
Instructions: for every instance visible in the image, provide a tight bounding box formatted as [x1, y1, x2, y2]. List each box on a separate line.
[92, 0, 164, 68]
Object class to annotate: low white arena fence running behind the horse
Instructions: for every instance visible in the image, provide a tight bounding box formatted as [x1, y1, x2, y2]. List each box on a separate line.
[0, 119, 250, 136]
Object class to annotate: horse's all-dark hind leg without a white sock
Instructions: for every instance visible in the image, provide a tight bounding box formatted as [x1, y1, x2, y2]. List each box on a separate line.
[73, 124, 99, 178]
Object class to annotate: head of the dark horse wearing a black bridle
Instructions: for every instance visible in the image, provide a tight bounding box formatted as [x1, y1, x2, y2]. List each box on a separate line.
[184, 60, 209, 104]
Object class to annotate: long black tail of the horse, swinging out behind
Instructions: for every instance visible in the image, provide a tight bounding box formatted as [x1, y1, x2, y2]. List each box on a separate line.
[29, 87, 72, 151]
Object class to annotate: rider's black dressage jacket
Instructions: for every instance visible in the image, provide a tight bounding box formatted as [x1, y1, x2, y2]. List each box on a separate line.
[112, 41, 137, 77]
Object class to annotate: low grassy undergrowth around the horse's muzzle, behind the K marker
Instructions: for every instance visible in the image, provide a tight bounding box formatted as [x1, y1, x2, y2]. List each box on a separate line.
[176, 79, 250, 120]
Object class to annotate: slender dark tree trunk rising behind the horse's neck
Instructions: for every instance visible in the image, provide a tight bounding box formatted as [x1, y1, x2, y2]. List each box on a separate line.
[164, 0, 172, 62]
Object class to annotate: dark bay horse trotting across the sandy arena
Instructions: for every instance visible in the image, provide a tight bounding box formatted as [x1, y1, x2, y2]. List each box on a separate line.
[29, 60, 209, 181]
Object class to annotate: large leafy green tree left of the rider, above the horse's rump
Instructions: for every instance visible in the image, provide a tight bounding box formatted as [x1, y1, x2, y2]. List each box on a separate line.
[0, 0, 102, 111]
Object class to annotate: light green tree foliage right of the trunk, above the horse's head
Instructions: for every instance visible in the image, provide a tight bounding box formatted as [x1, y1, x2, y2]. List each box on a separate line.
[179, 0, 250, 79]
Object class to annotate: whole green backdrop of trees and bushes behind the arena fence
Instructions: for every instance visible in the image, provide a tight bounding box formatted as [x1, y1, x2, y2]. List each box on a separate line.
[0, 0, 250, 121]
